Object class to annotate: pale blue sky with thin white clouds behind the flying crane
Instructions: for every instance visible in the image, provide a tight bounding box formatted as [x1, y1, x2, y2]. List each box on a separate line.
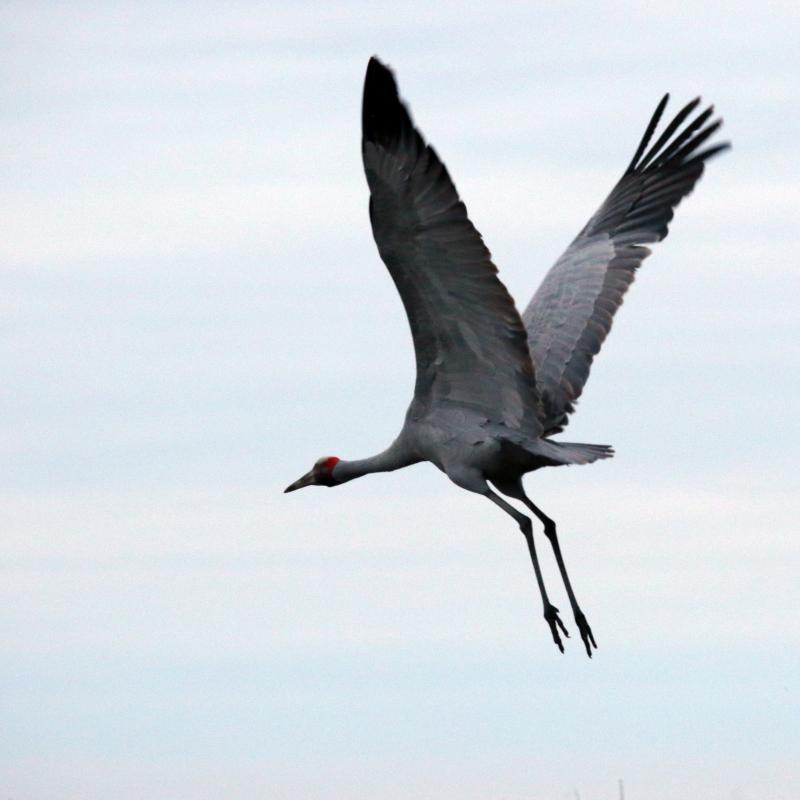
[0, 2, 800, 800]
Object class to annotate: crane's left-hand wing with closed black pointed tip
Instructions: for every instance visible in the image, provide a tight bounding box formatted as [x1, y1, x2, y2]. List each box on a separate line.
[362, 58, 541, 436]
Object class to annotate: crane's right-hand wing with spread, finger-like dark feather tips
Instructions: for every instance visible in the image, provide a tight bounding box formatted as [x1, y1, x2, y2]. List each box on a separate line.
[522, 95, 729, 434]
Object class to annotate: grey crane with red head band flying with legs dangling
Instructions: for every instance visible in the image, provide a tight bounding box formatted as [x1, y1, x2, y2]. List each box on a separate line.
[286, 58, 728, 656]
